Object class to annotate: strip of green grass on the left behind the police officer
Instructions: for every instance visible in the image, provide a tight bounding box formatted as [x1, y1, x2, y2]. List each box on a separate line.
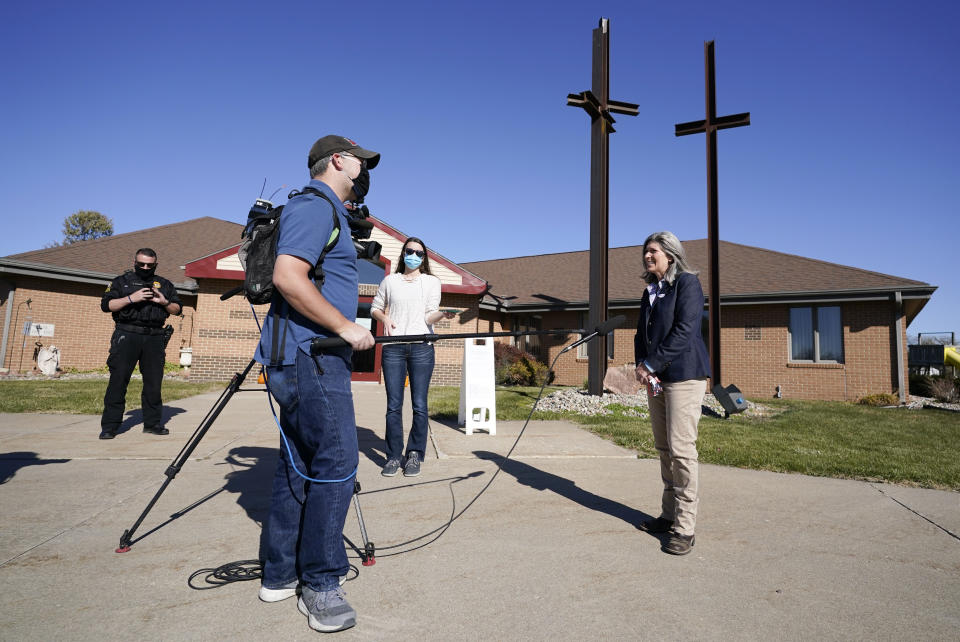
[0, 379, 227, 415]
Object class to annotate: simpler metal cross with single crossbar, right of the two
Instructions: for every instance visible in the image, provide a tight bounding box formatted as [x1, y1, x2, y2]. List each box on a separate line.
[674, 40, 750, 385]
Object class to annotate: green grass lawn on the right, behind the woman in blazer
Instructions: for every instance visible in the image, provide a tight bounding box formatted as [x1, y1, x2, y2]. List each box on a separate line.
[430, 387, 960, 490]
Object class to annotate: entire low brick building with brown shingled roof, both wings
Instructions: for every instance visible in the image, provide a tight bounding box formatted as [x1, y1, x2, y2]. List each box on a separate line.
[0, 217, 936, 399]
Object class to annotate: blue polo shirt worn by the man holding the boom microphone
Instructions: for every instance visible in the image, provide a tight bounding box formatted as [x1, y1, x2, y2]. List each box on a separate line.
[254, 180, 358, 365]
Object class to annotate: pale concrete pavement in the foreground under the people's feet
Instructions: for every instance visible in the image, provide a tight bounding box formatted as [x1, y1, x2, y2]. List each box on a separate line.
[0, 384, 960, 640]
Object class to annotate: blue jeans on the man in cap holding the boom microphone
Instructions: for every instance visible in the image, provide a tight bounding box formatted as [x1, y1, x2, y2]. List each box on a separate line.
[262, 347, 359, 591]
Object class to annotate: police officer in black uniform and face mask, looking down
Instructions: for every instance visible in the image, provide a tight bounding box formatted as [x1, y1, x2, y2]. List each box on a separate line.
[100, 247, 183, 439]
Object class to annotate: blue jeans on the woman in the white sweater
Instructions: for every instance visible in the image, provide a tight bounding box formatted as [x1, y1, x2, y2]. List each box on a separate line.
[381, 343, 433, 459]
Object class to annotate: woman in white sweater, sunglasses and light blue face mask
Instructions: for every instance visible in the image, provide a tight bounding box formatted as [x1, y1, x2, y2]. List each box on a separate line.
[371, 237, 454, 477]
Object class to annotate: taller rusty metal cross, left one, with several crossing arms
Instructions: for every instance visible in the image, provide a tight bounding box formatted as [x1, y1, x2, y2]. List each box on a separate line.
[567, 18, 640, 395]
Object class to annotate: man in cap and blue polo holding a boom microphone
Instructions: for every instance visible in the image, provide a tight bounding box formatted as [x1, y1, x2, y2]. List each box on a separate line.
[255, 135, 380, 632]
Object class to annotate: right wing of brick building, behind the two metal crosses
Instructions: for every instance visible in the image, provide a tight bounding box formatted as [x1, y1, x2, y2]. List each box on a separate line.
[463, 240, 936, 400]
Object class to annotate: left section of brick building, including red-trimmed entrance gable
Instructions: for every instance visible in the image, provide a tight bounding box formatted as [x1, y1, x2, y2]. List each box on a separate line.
[0, 217, 486, 385]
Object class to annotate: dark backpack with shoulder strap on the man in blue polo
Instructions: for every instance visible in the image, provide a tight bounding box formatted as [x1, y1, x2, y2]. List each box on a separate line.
[237, 187, 340, 305]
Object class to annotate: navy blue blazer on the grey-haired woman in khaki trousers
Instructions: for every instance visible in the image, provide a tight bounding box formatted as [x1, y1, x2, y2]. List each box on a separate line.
[633, 272, 710, 382]
